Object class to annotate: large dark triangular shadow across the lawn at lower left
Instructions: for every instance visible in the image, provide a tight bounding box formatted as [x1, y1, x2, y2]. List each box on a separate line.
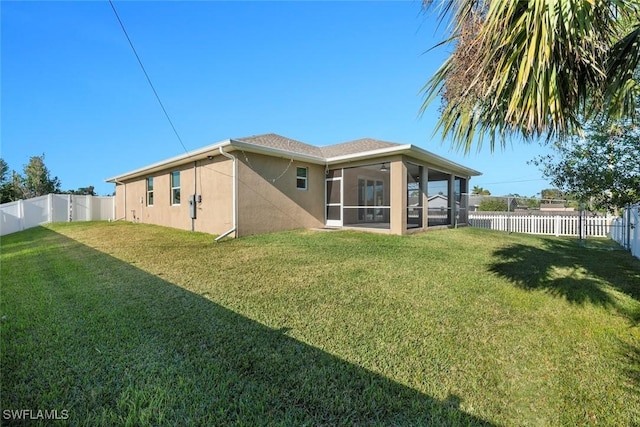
[0, 229, 490, 425]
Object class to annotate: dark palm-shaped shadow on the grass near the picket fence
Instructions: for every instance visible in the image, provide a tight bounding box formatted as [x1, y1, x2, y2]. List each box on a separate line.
[489, 238, 640, 323]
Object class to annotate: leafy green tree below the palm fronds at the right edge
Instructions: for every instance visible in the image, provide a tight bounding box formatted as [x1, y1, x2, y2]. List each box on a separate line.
[532, 117, 640, 210]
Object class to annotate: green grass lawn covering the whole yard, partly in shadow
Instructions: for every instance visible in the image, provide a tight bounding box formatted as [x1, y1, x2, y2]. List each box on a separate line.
[0, 223, 640, 426]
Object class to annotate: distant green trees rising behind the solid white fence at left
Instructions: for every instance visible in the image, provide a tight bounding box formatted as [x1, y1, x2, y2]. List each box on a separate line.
[0, 153, 96, 203]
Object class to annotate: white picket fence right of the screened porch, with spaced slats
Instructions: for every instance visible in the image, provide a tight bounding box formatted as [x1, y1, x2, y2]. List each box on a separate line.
[469, 212, 612, 237]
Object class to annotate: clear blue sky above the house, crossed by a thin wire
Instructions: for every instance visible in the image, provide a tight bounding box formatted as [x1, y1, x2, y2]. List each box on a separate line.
[0, 0, 550, 196]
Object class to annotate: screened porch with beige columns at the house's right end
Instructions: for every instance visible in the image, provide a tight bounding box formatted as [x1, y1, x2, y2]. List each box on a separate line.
[325, 157, 468, 234]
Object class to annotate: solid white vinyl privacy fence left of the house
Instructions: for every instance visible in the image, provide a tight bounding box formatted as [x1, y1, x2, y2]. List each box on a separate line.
[0, 194, 115, 236]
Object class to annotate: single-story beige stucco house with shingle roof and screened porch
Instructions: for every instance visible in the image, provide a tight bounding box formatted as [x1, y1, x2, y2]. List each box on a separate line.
[107, 134, 480, 238]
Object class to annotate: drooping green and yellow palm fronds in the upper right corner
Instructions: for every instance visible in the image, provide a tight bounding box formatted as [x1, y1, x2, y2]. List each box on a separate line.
[421, 0, 640, 152]
